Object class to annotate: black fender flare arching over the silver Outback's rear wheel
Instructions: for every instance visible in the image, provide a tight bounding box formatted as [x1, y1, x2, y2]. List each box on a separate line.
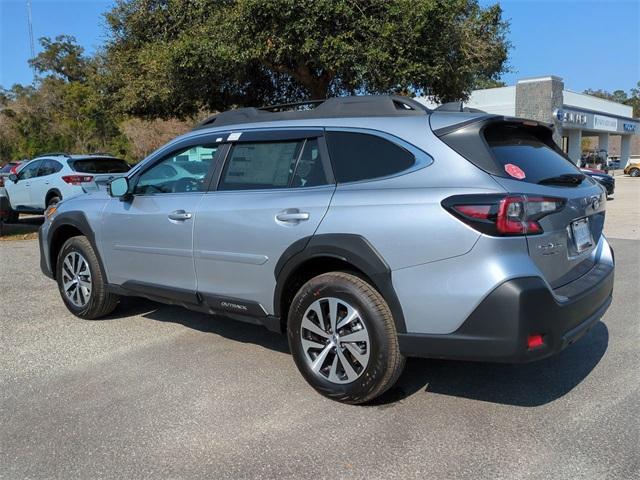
[273, 233, 407, 333]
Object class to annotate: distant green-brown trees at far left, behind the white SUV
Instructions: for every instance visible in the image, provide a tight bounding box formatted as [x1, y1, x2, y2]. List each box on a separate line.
[0, 37, 188, 162]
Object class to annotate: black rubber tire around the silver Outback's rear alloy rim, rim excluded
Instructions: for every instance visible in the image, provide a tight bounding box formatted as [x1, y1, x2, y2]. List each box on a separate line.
[287, 272, 405, 404]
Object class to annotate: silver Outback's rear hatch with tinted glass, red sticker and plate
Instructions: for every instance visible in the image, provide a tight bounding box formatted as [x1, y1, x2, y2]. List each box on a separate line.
[436, 116, 606, 288]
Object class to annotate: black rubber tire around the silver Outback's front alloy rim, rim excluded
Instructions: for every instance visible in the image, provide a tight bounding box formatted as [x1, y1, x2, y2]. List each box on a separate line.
[56, 236, 119, 320]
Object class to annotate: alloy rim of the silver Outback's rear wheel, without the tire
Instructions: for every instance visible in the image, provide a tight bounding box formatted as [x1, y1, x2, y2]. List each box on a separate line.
[300, 297, 371, 384]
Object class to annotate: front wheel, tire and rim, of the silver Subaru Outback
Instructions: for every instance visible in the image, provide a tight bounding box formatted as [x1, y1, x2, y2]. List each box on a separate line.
[56, 236, 118, 320]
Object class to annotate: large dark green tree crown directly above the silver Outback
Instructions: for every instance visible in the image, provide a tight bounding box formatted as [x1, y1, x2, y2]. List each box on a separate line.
[106, 0, 509, 117]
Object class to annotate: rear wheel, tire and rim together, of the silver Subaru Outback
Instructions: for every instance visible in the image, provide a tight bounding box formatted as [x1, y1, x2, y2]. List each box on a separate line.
[288, 272, 404, 404]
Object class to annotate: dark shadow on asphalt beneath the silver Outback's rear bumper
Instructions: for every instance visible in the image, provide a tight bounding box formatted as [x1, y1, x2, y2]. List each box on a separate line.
[372, 322, 609, 407]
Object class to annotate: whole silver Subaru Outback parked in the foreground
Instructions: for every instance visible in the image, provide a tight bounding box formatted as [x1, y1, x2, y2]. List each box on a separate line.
[40, 96, 614, 404]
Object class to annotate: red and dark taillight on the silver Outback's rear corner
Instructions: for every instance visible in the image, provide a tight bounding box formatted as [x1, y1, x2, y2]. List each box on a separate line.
[442, 194, 566, 236]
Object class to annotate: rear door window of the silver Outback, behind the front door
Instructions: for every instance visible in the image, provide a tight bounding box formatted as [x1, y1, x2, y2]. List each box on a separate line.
[218, 139, 327, 190]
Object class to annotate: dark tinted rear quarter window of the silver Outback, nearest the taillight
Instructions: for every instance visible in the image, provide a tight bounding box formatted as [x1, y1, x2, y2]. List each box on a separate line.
[327, 132, 415, 183]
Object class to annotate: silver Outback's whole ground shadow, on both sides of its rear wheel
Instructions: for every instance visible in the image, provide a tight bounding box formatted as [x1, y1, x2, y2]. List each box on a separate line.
[110, 298, 609, 407]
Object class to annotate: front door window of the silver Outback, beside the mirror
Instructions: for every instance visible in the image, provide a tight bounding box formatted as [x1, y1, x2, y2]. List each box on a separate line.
[134, 145, 217, 195]
